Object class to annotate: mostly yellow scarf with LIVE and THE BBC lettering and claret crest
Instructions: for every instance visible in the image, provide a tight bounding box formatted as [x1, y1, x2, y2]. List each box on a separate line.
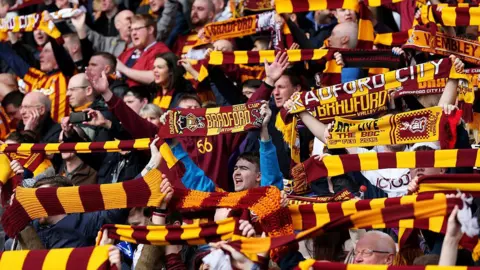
[327, 107, 462, 149]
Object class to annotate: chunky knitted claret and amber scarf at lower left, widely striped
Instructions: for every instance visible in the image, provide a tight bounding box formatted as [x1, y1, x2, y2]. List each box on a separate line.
[2, 169, 165, 237]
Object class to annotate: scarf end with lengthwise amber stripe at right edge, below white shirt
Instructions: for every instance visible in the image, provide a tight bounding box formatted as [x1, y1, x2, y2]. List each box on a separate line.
[418, 174, 480, 197]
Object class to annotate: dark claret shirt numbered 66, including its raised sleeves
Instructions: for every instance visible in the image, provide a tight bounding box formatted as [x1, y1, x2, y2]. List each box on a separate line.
[107, 84, 273, 190]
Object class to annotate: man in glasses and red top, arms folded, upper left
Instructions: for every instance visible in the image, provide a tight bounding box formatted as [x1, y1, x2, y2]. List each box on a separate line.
[115, 15, 170, 87]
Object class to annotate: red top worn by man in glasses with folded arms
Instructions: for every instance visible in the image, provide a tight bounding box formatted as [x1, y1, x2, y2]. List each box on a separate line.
[118, 41, 170, 87]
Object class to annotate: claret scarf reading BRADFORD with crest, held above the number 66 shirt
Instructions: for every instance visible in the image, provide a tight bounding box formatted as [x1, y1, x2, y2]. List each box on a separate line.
[159, 102, 263, 138]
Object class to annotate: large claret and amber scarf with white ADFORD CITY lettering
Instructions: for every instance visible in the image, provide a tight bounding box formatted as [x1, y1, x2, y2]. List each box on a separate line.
[289, 58, 474, 122]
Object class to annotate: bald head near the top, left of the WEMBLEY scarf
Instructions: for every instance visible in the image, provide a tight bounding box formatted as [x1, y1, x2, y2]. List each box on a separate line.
[328, 22, 358, 49]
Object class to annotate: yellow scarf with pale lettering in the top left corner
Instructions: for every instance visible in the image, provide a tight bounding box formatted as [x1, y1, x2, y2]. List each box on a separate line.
[0, 13, 62, 39]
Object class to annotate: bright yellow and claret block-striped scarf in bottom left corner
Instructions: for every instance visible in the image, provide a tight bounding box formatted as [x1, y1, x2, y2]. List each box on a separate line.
[0, 245, 117, 270]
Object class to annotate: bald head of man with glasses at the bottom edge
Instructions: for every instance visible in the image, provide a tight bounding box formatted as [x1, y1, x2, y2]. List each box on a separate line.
[354, 231, 397, 265]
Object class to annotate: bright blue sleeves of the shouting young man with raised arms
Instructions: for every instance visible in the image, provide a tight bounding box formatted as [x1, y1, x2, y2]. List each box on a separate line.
[172, 140, 283, 192]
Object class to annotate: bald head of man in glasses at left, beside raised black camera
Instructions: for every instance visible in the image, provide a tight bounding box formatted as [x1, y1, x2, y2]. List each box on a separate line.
[67, 73, 95, 108]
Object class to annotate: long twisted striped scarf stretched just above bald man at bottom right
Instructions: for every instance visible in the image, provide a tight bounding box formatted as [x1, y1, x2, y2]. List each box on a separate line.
[230, 196, 463, 253]
